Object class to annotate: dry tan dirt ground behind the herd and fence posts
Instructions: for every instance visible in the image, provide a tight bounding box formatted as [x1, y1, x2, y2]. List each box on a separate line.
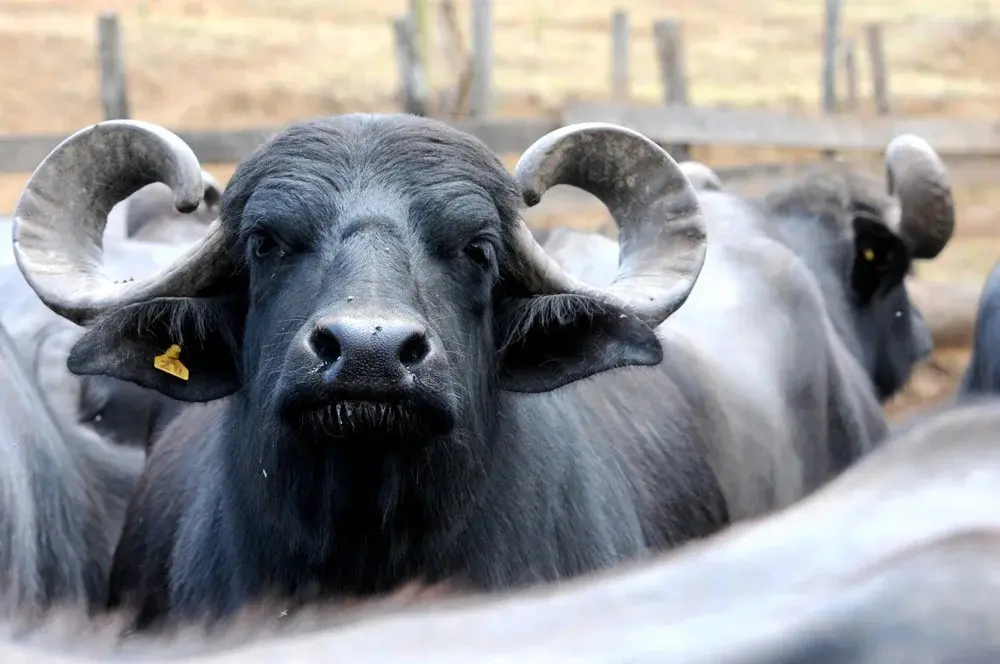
[0, 0, 1000, 415]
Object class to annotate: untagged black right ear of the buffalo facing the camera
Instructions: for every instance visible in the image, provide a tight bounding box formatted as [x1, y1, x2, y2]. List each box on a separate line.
[494, 295, 663, 392]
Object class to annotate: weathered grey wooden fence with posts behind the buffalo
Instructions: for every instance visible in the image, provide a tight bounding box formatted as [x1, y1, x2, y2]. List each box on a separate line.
[0, 0, 1000, 173]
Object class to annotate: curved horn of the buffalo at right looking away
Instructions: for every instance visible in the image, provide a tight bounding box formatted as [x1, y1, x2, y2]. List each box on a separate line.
[885, 134, 955, 258]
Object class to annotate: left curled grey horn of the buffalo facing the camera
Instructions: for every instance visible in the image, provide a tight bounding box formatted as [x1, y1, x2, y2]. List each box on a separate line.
[12, 120, 229, 325]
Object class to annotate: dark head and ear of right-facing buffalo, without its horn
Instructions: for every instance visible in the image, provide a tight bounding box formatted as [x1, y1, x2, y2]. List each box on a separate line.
[760, 165, 934, 402]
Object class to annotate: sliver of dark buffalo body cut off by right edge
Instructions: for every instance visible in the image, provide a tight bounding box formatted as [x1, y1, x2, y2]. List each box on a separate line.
[958, 263, 1000, 399]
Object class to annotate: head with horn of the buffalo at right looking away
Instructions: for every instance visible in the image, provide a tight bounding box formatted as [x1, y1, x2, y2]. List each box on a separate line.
[764, 135, 955, 400]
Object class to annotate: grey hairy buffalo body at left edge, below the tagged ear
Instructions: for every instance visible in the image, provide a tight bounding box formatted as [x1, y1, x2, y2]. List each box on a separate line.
[0, 325, 143, 616]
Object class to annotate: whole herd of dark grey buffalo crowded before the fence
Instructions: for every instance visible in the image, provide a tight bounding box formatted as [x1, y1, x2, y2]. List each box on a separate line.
[0, 114, 1000, 664]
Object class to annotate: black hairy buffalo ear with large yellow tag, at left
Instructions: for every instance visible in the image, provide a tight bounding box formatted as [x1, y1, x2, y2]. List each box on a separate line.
[66, 294, 246, 402]
